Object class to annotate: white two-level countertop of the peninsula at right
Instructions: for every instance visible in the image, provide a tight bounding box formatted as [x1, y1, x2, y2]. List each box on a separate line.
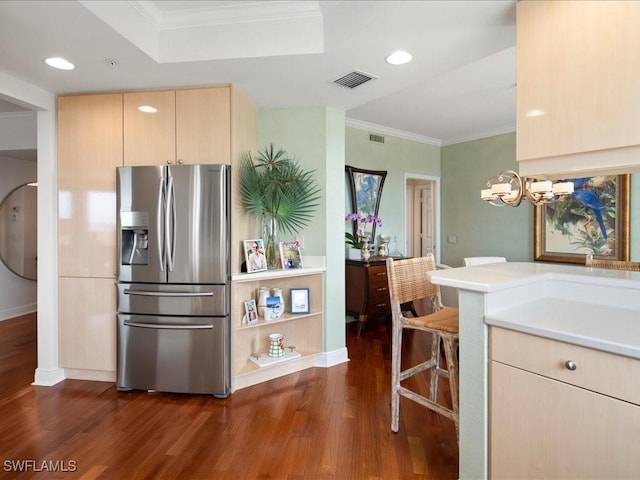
[429, 262, 640, 359]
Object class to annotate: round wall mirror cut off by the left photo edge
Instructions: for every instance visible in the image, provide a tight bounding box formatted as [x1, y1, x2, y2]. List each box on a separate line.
[0, 183, 38, 280]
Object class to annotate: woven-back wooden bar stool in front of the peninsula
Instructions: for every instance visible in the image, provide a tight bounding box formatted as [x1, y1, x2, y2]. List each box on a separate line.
[387, 254, 459, 435]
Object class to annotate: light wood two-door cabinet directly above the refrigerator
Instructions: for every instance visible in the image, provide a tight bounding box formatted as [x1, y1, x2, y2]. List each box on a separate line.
[124, 86, 231, 165]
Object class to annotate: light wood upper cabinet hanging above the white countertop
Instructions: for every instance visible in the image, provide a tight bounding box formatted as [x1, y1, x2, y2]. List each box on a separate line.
[516, 0, 640, 178]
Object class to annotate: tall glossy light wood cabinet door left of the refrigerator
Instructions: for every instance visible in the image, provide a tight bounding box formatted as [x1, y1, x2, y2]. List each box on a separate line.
[58, 93, 122, 280]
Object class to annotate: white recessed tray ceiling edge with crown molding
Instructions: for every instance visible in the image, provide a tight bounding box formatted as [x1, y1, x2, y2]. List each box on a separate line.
[83, 0, 324, 63]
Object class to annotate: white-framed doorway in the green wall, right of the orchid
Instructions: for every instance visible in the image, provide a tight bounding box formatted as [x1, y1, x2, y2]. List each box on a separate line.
[405, 174, 441, 263]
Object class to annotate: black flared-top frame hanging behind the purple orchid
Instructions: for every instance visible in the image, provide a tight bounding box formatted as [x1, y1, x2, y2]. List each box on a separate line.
[344, 165, 387, 239]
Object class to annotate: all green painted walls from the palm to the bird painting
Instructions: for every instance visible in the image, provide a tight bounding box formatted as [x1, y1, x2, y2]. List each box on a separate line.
[256, 107, 640, 352]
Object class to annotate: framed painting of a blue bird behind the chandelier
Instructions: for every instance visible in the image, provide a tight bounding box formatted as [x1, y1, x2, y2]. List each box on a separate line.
[534, 175, 629, 264]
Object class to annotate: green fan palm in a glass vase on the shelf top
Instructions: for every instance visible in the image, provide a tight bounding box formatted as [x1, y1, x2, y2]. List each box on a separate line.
[238, 143, 320, 268]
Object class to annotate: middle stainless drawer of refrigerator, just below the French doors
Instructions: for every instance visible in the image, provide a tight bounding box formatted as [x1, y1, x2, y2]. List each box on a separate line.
[117, 283, 230, 316]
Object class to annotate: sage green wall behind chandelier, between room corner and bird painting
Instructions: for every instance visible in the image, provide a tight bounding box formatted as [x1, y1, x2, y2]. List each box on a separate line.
[441, 133, 534, 267]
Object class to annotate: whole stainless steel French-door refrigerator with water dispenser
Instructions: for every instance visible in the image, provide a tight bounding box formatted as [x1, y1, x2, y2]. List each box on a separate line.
[117, 165, 231, 397]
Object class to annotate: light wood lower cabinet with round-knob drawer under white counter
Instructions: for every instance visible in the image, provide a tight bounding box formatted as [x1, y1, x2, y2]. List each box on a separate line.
[489, 328, 640, 479]
